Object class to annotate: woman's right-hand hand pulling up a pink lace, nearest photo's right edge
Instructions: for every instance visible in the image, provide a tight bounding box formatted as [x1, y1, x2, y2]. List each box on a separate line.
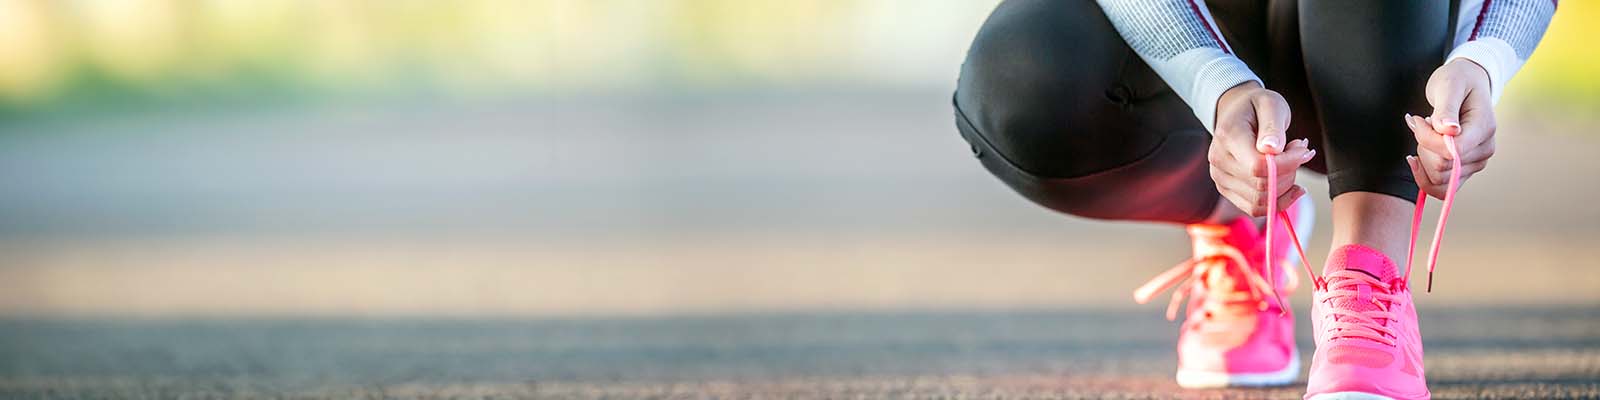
[1405, 59, 1494, 198]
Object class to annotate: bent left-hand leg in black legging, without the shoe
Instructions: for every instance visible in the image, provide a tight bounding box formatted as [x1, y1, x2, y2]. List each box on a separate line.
[954, 0, 1230, 224]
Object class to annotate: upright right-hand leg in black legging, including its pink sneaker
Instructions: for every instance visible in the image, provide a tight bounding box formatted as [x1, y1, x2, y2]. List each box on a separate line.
[1299, 0, 1451, 400]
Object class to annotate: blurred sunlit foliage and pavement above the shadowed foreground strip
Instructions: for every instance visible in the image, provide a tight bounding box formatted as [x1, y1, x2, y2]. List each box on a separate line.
[0, 0, 1600, 317]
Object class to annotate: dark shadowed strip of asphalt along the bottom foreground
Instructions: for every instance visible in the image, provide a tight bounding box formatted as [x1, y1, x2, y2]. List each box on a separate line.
[0, 307, 1600, 398]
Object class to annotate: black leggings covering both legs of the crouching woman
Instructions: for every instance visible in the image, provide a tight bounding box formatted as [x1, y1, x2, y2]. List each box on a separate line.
[954, 0, 1453, 224]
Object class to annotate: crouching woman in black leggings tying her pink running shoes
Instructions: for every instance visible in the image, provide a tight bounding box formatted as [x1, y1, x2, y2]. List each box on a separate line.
[954, 0, 1557, 398]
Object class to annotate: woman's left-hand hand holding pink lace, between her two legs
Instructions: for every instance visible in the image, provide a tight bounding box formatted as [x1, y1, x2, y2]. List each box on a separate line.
[1206, 82, 1317, 216]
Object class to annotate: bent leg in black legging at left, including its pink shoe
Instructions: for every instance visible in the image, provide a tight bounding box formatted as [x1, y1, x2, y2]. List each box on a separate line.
[955, 0, 1309, 387]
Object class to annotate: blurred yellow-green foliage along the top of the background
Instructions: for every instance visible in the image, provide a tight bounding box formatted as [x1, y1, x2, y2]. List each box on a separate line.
[0, 0, 1600, 112]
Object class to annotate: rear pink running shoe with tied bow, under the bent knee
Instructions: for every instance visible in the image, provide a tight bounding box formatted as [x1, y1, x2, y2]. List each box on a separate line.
[1133, 200, 1315, 389]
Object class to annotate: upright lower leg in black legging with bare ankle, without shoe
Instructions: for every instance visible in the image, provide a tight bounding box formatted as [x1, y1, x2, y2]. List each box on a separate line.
[1299, 0, 1451, 267]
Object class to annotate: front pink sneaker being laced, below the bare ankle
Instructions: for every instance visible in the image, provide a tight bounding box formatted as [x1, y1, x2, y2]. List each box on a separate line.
[1306, 245, 1430, 400]
